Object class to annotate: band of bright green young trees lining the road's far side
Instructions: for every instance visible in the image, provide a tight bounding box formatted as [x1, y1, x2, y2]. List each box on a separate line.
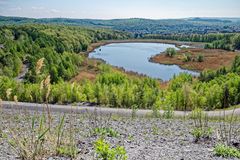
[0, 62, 240, 111]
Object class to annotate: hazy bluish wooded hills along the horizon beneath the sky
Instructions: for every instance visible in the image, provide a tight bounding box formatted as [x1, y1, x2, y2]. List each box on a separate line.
[0, 16, 240, 36]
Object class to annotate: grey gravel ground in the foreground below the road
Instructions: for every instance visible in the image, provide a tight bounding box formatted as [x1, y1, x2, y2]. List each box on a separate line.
[0, 109, 240, 160]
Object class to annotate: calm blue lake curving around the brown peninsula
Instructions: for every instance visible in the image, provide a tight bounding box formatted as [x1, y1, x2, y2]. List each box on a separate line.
[89, 43, 199, 81]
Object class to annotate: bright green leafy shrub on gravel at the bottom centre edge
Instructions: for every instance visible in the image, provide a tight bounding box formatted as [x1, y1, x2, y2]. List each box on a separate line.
[94, 139, 127, 160]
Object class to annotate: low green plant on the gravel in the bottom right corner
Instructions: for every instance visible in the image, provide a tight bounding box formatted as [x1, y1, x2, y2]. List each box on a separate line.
[214, 144, 240, 158]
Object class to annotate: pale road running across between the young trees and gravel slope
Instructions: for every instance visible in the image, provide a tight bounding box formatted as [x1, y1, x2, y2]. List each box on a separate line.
[0, 101, 240, 117]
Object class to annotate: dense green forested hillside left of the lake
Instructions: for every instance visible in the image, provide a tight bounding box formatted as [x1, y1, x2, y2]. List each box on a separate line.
[0, 25, 129, 82]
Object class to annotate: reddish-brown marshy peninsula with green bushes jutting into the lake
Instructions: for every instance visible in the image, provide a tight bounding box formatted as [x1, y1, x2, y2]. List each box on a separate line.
[151, 48, 238, 71]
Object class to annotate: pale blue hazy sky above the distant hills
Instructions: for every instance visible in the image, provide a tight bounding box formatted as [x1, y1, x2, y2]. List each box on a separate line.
[0, 0, 240, 19]
